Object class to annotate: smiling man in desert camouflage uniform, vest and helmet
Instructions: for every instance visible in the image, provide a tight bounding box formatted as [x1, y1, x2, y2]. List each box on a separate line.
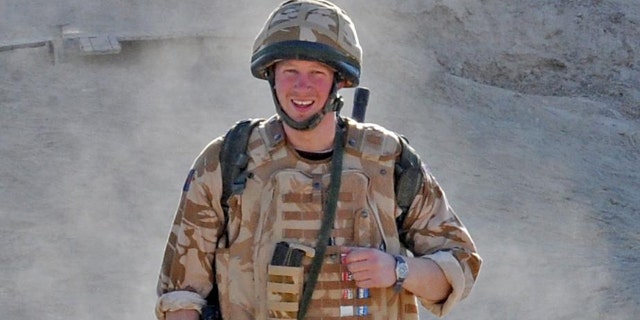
[156, 0, 481, 320]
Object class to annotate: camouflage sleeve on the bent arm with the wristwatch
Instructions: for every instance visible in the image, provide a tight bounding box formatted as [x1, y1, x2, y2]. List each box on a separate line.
[401, 168, 482, 317]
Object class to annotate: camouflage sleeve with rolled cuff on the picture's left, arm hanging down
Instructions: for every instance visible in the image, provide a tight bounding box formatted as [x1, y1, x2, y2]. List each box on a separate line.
[156, 139, 224, 319]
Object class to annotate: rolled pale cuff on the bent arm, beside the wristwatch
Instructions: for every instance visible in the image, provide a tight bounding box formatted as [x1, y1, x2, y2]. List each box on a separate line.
[418, 251, 465, 317]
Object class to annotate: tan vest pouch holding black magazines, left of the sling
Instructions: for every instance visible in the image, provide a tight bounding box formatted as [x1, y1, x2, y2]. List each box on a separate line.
[267, 242, 315, 319]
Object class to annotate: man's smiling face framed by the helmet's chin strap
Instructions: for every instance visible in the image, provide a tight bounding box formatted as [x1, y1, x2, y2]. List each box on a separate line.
[275, 60, 334, 121]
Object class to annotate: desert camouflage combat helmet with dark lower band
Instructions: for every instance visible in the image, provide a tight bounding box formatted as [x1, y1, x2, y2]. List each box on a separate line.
[251, 0, 362, 88]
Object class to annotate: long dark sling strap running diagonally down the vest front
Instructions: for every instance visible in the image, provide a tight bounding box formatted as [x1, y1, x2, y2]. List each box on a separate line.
[298, 118, 346, 320]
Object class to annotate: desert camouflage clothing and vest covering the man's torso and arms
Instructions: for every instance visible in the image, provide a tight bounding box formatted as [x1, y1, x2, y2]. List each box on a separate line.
[158, 117, 481, 319]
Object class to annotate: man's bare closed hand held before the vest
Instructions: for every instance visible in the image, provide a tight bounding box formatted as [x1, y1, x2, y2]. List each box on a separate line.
[343, 247, 396, 288]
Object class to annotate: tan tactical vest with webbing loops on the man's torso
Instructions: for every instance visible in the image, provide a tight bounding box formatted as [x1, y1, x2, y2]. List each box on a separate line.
[215, 118, 418, 319]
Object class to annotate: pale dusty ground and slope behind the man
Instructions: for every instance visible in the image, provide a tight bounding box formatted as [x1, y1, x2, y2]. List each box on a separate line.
[0, 0, 640, 320]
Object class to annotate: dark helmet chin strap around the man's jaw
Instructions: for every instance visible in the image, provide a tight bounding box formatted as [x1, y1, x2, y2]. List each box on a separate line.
[267, 72, 344, 131]
